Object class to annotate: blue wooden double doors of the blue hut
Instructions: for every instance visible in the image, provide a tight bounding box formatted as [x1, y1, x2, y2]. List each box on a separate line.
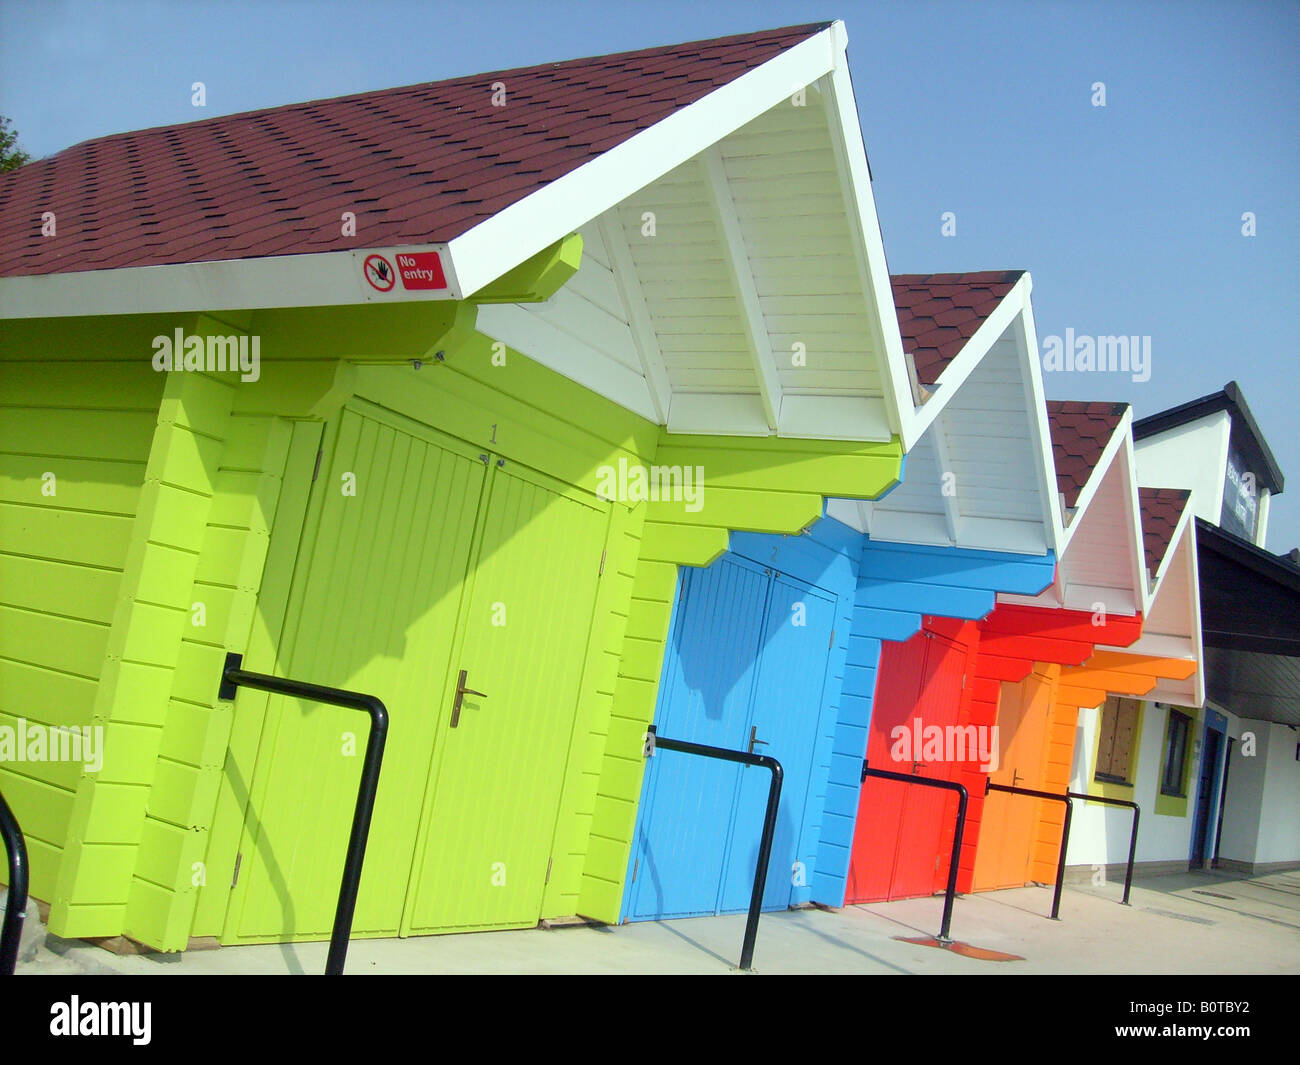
[624, 555, 836, 921]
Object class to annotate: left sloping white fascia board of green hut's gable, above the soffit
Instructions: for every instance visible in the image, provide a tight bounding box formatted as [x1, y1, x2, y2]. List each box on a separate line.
[450, 27, 836, 296]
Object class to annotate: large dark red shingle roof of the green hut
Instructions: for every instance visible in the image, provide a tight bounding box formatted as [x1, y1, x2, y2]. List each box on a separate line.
[0, 23, 829, 277]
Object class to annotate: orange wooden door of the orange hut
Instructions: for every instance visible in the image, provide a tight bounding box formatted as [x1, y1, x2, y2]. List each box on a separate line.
[971, 670, 1053, 891]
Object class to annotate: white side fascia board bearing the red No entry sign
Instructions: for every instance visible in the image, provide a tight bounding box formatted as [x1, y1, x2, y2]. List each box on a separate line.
[0, 244, 460, 319]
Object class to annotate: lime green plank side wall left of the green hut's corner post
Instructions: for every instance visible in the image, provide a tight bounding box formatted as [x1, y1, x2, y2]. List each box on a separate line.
[0, 351, 164, 900]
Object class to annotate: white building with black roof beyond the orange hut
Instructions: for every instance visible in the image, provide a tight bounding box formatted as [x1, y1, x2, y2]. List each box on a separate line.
[1067, 382, 1300, 878]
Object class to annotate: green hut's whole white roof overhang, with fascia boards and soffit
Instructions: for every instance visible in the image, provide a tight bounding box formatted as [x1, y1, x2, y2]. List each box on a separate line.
[0, 22, 919, 447]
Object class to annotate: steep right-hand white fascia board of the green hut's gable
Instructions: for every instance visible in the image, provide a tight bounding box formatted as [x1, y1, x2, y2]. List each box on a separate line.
[823, 21, 922, 453]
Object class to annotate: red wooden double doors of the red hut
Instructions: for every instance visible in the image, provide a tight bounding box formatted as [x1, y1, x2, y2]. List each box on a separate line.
[846, 627, 969, 902]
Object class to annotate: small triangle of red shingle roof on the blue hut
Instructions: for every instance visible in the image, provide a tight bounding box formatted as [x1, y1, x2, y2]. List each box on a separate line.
[889, 270, 1024, 385]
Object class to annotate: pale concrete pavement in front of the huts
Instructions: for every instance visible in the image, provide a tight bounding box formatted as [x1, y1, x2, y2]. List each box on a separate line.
[18, 871, 1300, 975]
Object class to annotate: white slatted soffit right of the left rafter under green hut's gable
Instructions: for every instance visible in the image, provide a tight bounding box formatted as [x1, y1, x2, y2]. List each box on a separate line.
[616, 91, 883, 408]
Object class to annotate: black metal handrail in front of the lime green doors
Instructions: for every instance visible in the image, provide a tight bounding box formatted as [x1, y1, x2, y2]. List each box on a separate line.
[220, 651, 389, 977]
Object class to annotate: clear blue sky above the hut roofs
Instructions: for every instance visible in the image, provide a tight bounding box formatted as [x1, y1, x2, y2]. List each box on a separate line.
[0, 0, 1300, 551]
